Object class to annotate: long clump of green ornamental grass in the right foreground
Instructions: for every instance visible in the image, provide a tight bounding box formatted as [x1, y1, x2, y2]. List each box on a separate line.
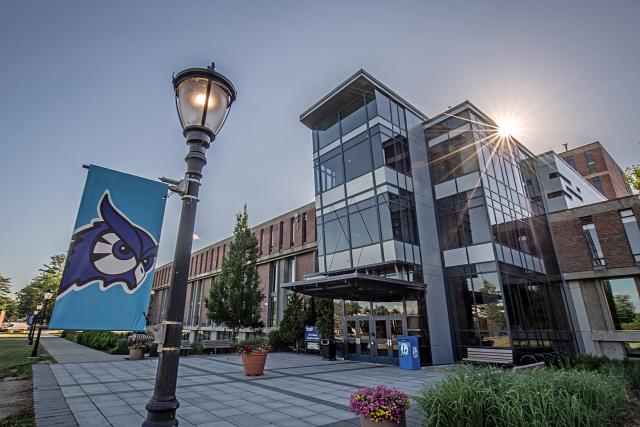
[416, 367, 626, 427]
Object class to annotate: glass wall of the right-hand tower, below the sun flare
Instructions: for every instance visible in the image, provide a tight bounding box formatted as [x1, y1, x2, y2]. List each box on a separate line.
[425, 109, 573, 358]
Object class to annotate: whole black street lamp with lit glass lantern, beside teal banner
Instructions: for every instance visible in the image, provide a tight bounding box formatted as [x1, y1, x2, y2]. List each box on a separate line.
[143, 63, 236, 427]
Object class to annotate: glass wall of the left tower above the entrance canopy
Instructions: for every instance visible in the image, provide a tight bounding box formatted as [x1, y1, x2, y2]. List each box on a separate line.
[313, 89, 420, 272]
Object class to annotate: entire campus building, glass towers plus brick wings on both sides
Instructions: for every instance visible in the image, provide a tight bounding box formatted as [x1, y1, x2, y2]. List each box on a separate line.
[150, 70, 640, 364]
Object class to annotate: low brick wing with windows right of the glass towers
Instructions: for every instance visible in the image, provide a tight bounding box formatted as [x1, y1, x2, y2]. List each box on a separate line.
[549, 196, 640, 358]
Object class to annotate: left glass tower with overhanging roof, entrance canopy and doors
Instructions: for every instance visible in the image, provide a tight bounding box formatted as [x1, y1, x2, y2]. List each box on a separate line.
[291, 70, 453, 363]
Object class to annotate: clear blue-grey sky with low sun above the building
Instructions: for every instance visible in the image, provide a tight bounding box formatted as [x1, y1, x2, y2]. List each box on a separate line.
[0, 0, 640, 290]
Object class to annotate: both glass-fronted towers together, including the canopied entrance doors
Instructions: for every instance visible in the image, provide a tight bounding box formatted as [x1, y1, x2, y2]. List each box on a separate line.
[298, 71, 574, 364]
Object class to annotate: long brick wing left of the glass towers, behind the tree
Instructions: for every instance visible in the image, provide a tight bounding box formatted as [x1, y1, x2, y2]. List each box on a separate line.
[149, 203, 316, 341]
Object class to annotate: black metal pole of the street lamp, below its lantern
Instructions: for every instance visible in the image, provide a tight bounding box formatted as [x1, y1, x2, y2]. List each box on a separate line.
[142, 131, 213, 427]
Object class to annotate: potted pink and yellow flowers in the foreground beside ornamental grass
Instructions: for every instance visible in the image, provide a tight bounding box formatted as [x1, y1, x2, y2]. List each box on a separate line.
[349, 385, 409, 427]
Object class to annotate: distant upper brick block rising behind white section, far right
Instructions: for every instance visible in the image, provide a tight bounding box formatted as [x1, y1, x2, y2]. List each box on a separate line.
[558, 141, 633, 199]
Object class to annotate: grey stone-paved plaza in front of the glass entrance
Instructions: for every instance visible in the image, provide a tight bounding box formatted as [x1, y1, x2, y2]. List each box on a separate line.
[36, 353, 446, 427]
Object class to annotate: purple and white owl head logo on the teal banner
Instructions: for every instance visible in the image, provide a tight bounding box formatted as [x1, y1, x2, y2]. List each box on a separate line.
[58, 190, 158, 298]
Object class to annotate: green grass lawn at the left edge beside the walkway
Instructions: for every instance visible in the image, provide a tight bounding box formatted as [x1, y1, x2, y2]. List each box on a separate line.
[0, 339, 53, 379]
